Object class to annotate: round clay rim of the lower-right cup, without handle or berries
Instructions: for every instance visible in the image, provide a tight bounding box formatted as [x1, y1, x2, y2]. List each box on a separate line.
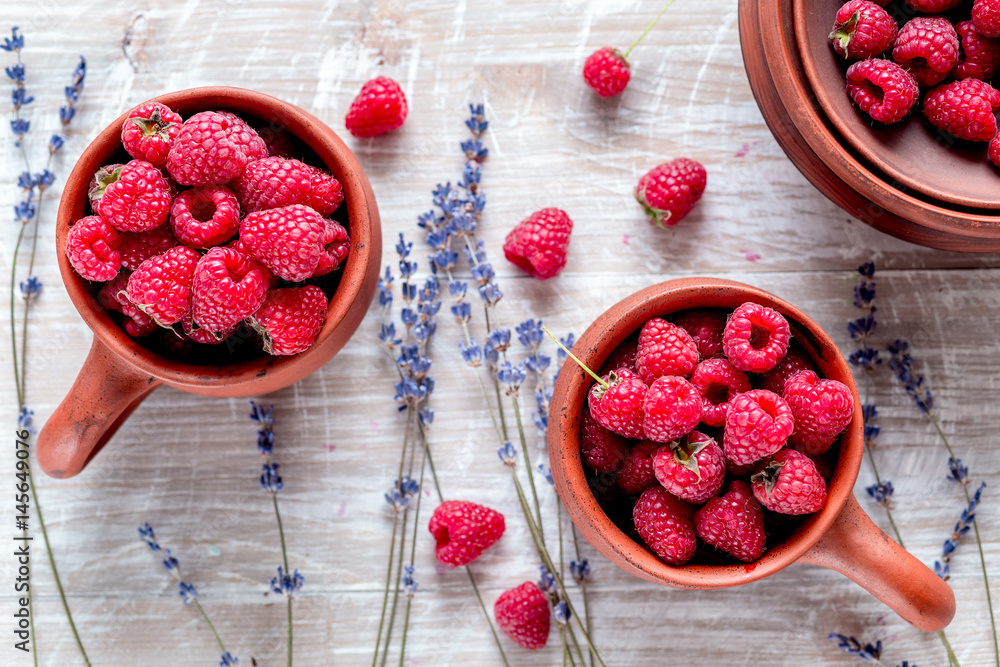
[547, 278, 864, 588]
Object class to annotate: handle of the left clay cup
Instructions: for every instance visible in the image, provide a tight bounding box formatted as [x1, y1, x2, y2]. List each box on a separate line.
[35, 338, 161, 477]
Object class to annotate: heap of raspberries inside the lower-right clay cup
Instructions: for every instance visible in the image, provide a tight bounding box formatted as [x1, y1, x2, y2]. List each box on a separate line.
[580, 302, 854, 565]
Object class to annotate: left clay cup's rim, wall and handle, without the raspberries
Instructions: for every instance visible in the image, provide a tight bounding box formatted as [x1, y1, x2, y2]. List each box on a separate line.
[37, 87, 382, 477]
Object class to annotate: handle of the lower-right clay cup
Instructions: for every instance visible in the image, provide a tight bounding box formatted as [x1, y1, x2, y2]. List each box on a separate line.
[801, 494, 955, 632]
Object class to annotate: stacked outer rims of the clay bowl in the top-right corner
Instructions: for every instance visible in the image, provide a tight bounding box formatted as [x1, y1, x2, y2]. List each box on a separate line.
[739, 0, 1000, 252]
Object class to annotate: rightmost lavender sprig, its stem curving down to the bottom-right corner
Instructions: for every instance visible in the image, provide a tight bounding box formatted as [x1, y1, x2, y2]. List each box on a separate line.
[888, 339, 1000, 667]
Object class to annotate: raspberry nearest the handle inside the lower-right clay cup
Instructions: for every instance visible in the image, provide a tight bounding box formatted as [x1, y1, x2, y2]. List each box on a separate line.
[750, 449, 826, 514]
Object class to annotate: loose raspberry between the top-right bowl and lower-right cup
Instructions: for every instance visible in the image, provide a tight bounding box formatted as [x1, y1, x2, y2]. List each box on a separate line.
[635, 157, 708, 227]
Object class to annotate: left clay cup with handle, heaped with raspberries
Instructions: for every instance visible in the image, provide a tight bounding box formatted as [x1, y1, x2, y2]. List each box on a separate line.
[38, 87, 381, 477]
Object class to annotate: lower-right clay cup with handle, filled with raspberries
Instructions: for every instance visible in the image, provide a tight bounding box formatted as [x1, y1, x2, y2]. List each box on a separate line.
[548, 278, 955, 631]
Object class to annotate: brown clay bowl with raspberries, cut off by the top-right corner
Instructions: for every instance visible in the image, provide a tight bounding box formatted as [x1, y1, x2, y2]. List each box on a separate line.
[740, 0, 1000, 252]
